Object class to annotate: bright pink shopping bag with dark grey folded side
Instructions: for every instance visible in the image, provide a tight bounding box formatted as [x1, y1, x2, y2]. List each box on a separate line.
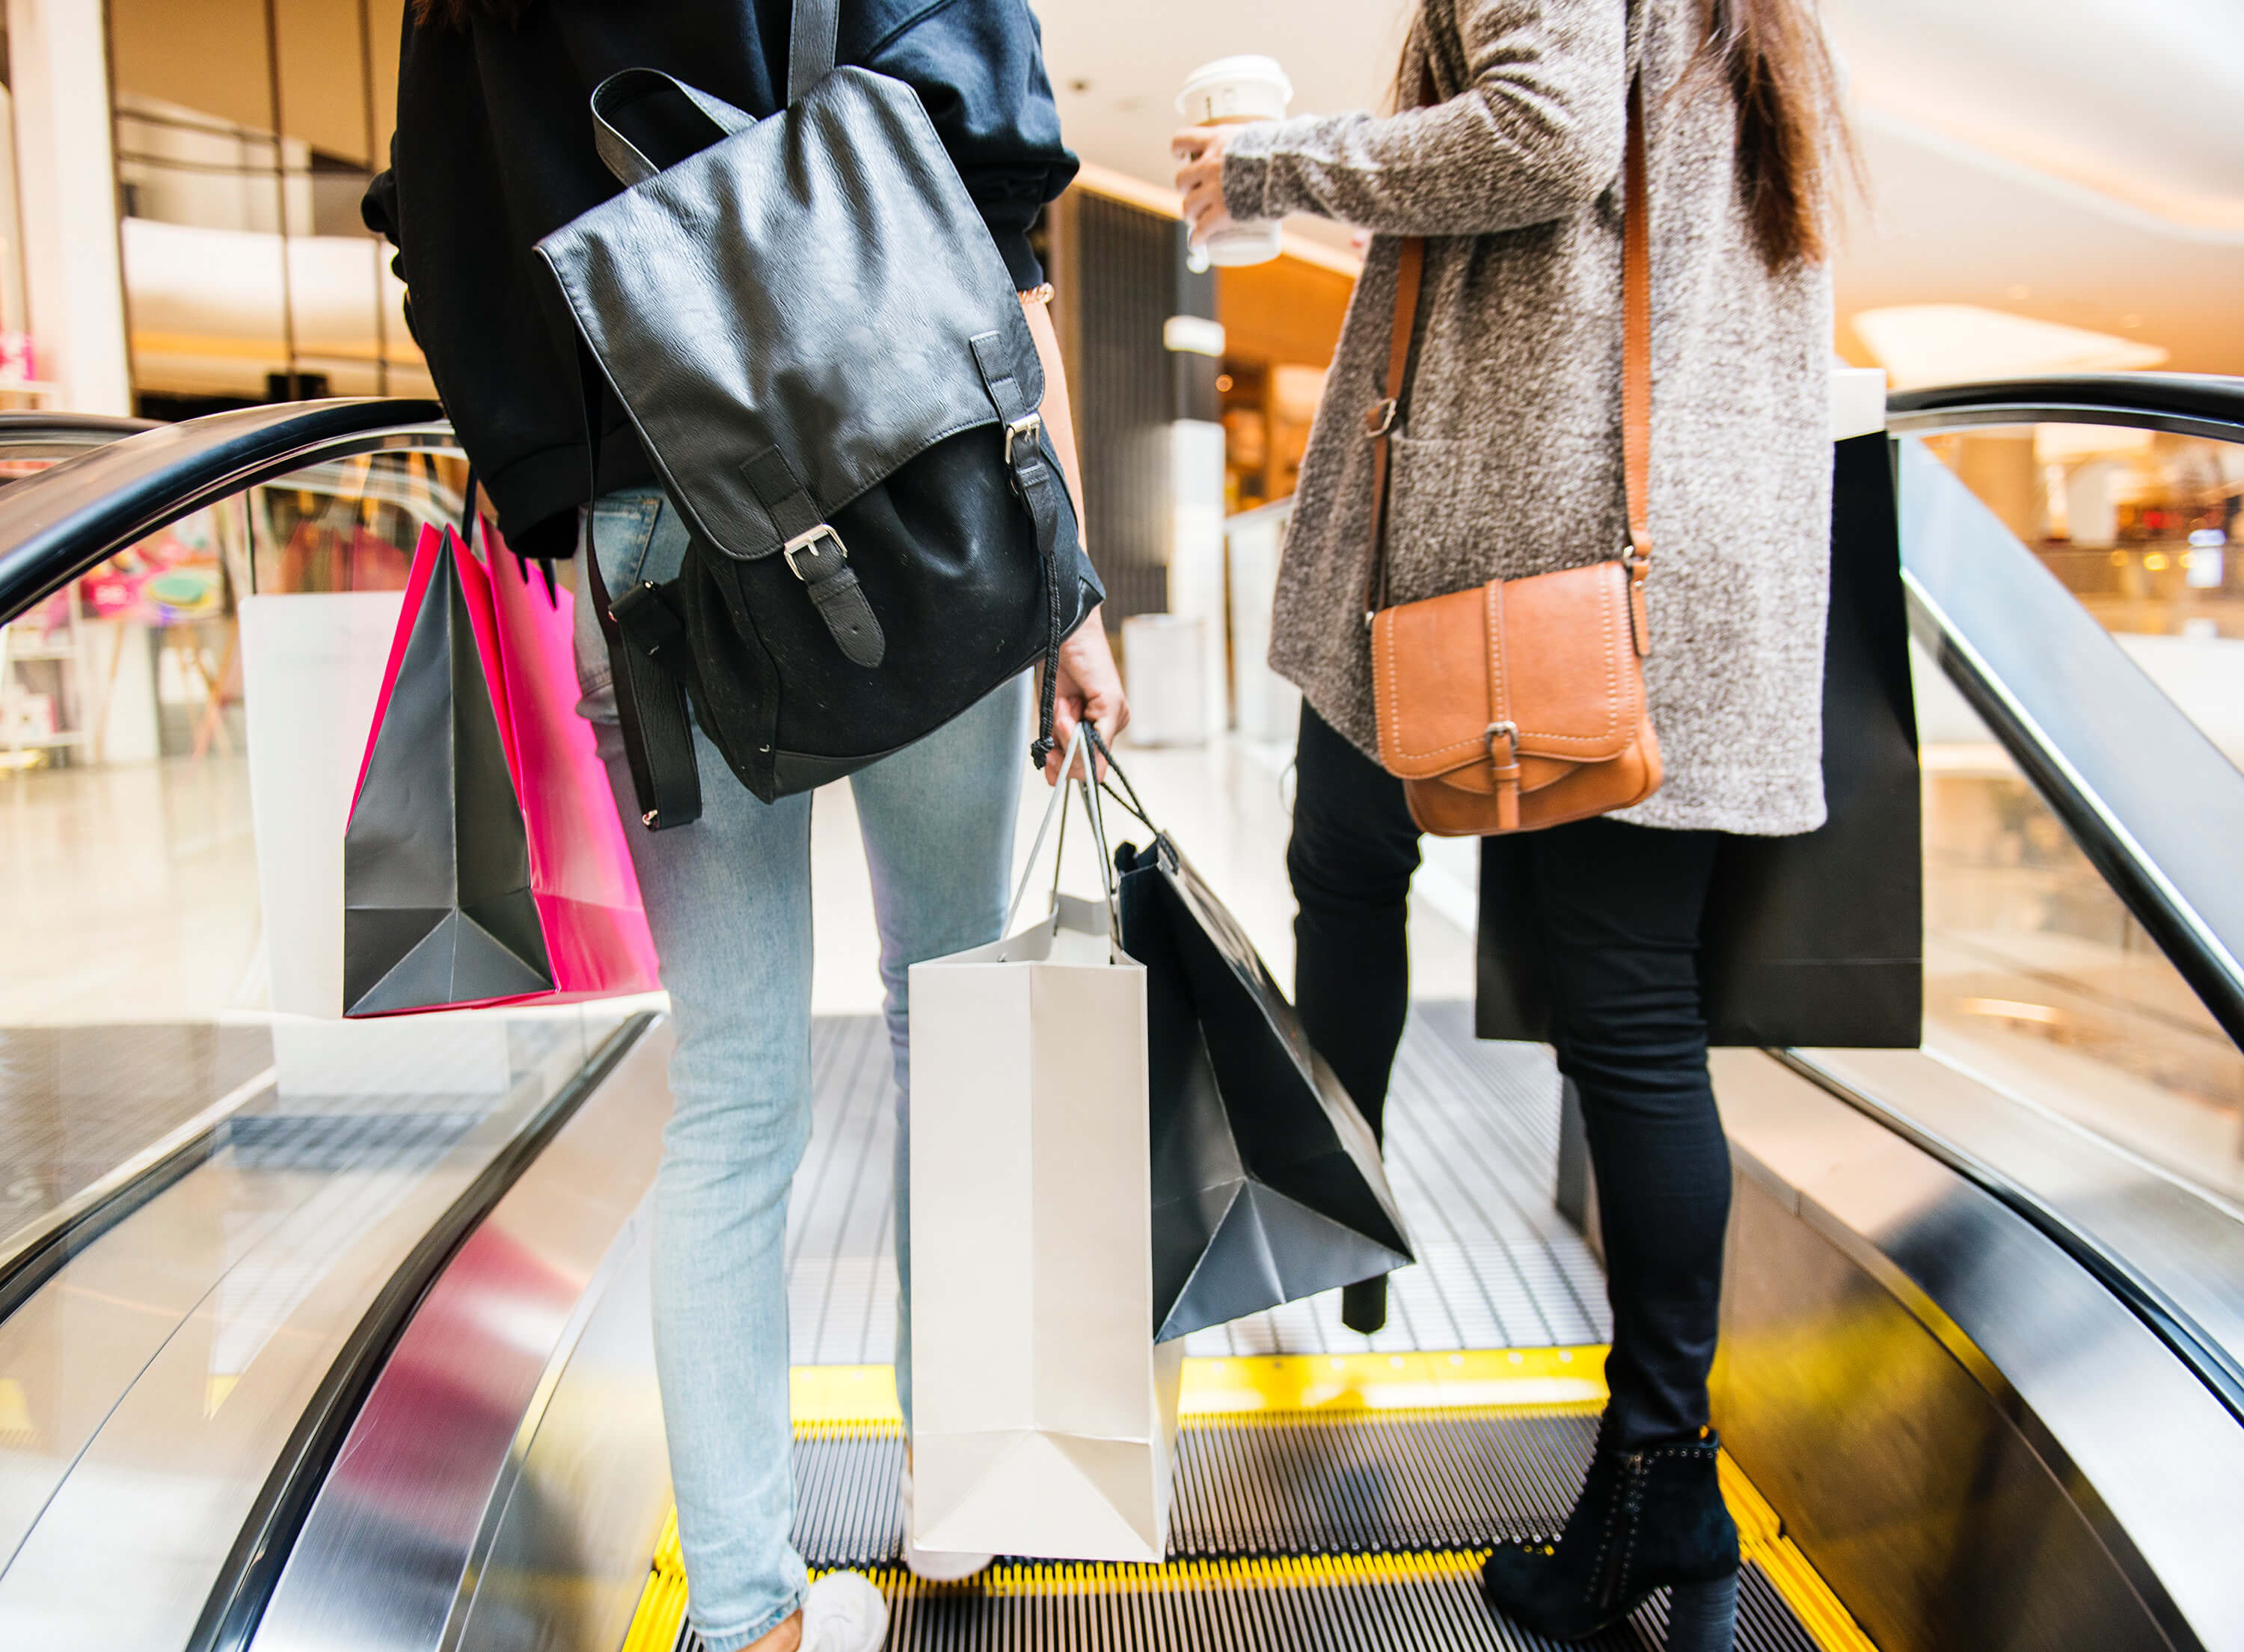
[343, 523, 655, 1017]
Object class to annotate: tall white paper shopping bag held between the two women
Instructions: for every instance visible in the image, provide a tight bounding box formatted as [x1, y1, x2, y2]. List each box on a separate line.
[911, 752, 1183, 1560]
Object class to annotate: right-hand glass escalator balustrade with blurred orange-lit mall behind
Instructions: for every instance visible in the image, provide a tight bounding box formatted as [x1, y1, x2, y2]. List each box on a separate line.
[1905, 424, 2244, 1203]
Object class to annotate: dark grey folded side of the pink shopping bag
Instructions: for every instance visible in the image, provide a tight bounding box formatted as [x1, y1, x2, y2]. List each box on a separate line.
[343, 529, 554, 1015]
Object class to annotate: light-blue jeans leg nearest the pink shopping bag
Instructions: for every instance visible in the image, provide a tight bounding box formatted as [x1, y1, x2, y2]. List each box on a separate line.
[595, 722, 810, 1652]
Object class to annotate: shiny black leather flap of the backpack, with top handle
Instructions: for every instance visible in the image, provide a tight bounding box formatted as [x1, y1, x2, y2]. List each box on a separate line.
[539, 67, 1043, 559]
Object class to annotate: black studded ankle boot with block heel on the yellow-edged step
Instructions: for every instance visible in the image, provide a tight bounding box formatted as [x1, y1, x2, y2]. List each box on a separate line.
[1481, 1430, 1737, 1652]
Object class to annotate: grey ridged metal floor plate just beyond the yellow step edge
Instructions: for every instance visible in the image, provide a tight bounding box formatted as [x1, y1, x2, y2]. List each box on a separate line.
[788, 1001, 1609, 1365]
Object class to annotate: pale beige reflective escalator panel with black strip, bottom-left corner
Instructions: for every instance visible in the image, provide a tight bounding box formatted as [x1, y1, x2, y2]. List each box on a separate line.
[0, 1013, 655, 1652]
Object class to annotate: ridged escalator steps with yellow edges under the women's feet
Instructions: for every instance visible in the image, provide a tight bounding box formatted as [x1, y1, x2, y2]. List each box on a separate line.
[626, 1349, 1876, 1652]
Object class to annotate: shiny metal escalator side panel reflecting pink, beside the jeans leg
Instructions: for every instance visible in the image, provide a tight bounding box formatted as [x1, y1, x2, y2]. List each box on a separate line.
[245, 1033, 671, 1652]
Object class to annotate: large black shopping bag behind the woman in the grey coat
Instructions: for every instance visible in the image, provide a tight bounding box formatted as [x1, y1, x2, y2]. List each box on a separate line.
[1474, 433, 1925, 1051]
